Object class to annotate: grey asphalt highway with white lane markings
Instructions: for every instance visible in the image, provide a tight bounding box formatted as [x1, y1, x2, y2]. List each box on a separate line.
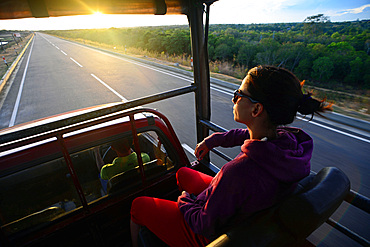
[0, 33, 370, 246]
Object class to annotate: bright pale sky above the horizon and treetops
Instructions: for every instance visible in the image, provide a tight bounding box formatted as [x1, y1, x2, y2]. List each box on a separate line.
[0, 0, 370, 30]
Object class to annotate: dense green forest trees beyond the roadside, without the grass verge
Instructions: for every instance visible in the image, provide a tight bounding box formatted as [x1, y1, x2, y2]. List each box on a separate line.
[46, 18, 370, 89]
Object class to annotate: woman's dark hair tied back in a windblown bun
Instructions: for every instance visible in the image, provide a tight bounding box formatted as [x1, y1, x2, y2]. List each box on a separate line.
[245, 65, 331, 125]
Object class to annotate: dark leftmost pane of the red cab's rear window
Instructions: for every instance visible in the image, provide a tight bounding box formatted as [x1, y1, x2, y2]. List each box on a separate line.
[0, 158, 81, 234]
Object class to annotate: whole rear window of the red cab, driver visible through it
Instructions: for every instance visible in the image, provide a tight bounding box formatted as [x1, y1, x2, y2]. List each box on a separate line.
[0, 128, 176, 234]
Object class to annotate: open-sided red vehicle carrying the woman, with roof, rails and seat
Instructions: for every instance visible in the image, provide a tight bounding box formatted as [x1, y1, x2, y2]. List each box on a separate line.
[0, 0, 369, 246]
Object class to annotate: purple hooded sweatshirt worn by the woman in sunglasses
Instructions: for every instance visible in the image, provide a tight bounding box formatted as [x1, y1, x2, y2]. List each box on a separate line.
[177, 128, 313, 240]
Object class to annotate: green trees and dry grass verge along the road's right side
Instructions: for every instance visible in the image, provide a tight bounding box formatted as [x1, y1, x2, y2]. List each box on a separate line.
[3, 14, 370, 118]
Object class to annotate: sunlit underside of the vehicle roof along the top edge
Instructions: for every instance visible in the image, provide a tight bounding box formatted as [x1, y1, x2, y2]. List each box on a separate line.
[0, 0, 217, 19]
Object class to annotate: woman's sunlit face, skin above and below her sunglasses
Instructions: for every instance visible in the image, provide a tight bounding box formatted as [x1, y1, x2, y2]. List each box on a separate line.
[233, 76, 254, 126]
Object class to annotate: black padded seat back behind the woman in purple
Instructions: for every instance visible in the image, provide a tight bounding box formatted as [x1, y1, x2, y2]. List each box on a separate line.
[208, 167, 350, 247]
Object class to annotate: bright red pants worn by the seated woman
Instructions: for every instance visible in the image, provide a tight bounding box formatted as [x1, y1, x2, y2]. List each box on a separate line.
[131, 167, 213, 247]
